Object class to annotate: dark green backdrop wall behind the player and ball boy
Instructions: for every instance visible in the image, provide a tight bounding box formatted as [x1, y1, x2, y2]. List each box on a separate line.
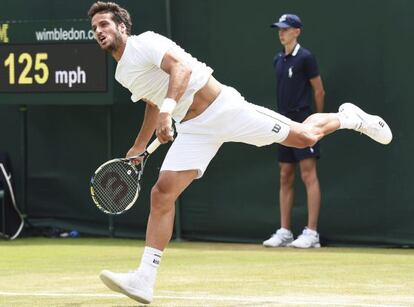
[0, 0, 414, 245]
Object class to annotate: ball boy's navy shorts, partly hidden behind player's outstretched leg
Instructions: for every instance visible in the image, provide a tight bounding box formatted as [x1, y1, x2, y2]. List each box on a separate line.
[278, 109, 320, 163]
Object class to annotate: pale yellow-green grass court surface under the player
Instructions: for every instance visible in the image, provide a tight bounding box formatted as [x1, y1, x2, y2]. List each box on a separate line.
[0, 238, 414, 307]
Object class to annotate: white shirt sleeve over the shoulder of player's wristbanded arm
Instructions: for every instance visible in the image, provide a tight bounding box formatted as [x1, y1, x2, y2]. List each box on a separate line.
[136, 31, 175, 67]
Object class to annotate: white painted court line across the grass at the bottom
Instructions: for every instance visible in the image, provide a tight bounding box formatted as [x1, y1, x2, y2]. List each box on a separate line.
[0, 291, 414, 307]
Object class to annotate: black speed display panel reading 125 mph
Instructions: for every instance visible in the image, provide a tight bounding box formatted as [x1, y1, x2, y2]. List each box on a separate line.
[0, 43, 107, 93]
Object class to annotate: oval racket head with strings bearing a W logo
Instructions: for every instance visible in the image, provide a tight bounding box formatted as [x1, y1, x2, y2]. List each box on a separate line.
[92, 161, 142, 214]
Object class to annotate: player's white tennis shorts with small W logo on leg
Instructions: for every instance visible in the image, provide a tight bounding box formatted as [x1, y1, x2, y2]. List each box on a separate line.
[161, 86, 291, 178]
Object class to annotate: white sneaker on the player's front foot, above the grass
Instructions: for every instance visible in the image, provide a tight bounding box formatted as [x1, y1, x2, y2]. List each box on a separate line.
[99, 270, 154, 304]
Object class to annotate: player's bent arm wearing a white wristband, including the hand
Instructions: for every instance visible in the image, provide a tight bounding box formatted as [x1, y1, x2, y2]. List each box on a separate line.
[156, 50, 191, 143]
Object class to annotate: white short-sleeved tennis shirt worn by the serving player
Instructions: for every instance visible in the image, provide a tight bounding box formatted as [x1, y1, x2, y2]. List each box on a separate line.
[115, 31, 213, 122]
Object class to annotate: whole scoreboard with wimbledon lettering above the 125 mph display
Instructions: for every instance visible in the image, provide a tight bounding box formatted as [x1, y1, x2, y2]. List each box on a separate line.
[0, 20, 114, 105]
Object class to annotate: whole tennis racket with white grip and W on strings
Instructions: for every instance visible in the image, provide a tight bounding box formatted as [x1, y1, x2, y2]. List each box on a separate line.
[90, 139, 161, 215]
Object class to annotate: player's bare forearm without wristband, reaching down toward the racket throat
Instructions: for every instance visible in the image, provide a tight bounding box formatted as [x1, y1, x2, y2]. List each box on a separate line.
[126, 99, 159, 158]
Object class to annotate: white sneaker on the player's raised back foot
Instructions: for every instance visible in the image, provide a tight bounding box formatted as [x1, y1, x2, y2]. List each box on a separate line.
[339, 102, 392, 145]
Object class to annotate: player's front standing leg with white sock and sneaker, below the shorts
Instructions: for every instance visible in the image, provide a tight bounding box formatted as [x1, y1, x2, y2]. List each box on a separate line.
[100, 170, 198, 304]
